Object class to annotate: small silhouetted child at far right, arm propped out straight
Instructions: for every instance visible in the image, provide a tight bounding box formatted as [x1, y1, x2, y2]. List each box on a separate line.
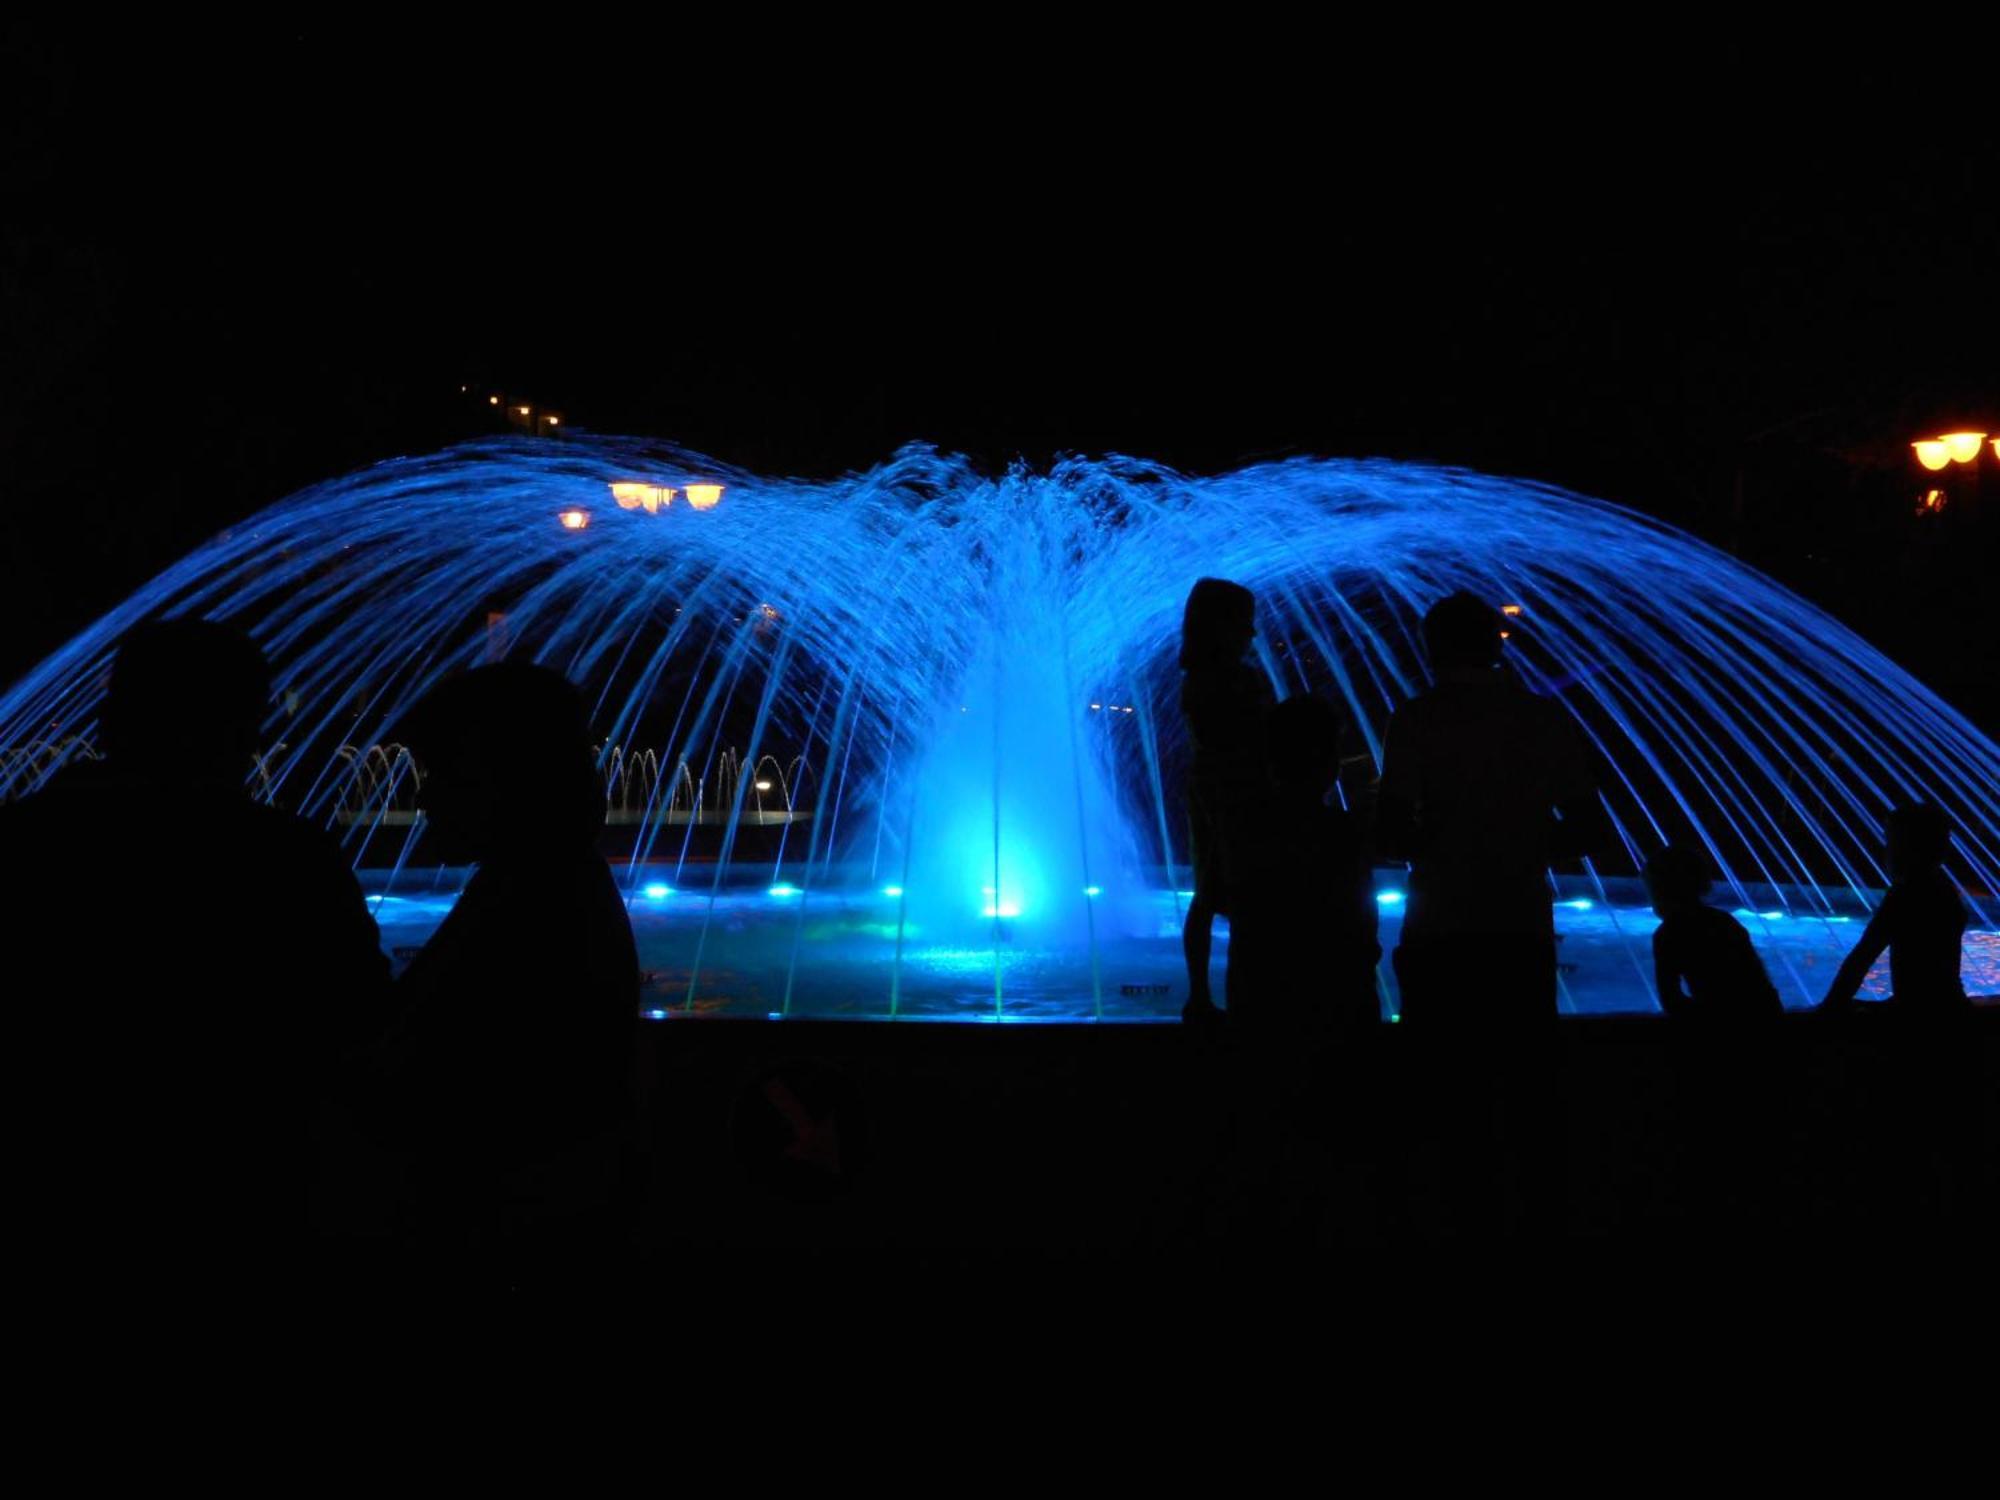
[1824, 804, 1968, 1016]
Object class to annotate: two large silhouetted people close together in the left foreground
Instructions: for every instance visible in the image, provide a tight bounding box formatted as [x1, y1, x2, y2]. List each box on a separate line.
[0, 636, 640, 1286]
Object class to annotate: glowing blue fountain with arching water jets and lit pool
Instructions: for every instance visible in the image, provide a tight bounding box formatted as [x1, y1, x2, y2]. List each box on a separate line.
[0, 438, 2000, 1018]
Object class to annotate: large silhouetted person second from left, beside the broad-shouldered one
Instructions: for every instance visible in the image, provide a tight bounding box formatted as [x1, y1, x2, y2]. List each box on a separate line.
[364, 664, 640, 1246]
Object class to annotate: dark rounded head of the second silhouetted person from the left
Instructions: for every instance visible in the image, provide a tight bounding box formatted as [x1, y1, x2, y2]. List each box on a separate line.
[394, 662, 604, 864]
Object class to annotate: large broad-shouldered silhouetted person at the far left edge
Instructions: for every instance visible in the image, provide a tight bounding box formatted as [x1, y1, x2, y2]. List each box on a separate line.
[0, 620, 388, 1282]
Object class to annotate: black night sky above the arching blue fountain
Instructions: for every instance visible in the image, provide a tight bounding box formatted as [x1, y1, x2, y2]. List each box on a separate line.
[0, 32, 2000, 728]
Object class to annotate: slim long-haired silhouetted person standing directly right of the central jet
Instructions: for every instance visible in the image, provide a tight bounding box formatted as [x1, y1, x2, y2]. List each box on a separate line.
[1180, 578, 1272, 1022]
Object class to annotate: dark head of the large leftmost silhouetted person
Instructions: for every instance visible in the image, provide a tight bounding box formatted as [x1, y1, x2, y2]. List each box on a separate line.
[104, 620, 270, 786]
